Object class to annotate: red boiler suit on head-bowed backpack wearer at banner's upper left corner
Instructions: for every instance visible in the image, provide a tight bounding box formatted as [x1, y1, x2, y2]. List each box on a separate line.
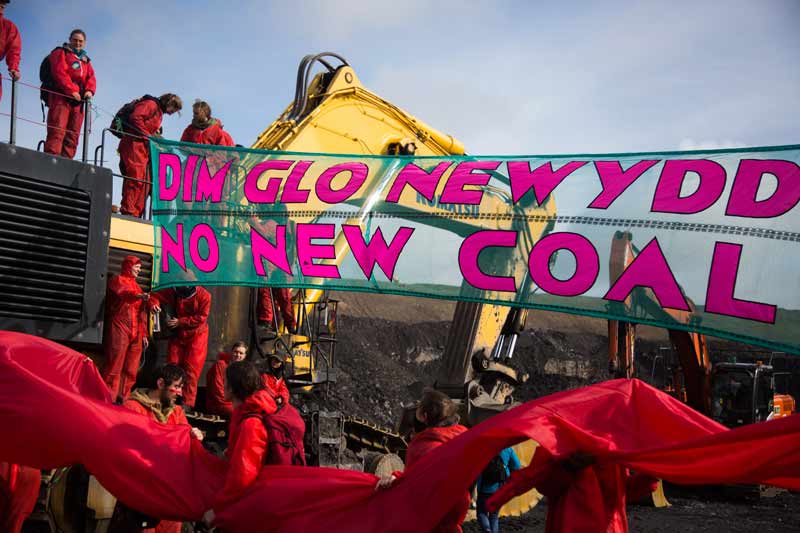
[119, 99, 164, 218]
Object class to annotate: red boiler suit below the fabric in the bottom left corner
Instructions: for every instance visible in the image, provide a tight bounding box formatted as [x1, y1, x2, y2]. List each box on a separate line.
[0, 462, 42, 533]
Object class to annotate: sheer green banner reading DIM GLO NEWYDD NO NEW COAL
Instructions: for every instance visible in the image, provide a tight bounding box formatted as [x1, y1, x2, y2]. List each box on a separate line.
[150, 139, 800, 353]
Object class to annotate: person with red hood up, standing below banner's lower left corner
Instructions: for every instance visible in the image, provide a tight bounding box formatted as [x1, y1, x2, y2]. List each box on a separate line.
[103, 255, 157, 399]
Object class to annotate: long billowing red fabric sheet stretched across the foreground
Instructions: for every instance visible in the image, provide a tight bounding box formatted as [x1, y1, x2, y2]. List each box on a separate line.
[0, 332, 800, 532]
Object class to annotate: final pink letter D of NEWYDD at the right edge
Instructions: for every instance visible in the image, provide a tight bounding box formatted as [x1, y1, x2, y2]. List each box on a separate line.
[725, 159, 800, 218]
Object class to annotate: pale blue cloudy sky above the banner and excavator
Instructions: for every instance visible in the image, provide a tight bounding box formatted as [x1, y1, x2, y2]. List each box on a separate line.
[0, 0, 800, 167]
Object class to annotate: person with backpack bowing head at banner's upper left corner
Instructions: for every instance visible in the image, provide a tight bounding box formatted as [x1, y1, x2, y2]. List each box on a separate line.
[117, 93, 183, 218]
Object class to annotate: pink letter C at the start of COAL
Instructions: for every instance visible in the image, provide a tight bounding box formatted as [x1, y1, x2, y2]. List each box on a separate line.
[458, 230, 517, 292]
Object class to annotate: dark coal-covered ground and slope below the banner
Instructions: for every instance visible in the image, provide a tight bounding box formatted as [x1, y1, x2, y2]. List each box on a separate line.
[315, 294, 800, 533]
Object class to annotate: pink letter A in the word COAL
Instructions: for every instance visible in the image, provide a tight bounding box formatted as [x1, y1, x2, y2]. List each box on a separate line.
[603, 238, 689, 311]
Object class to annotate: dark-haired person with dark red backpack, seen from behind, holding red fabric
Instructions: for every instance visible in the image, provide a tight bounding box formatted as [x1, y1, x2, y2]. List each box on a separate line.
[203, 361, 305, 524]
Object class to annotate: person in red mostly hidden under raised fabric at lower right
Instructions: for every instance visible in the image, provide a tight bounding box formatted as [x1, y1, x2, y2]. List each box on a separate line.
[510, 448, 658, 533]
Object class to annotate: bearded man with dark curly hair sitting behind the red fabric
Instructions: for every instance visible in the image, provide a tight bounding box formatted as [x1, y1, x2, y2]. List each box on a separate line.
[119, 364, 203, 533]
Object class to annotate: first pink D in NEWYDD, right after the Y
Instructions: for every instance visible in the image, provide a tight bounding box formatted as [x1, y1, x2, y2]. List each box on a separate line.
[650, 159, 725, 215]
